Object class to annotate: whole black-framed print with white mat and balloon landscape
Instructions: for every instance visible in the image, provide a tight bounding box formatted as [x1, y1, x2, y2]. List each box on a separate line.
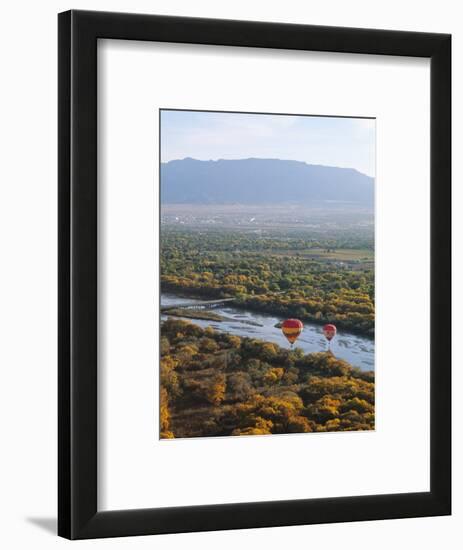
[58, 11, 451, 539]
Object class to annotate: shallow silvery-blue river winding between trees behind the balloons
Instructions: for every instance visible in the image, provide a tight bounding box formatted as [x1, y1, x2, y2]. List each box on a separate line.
[161, 293, 375, 371]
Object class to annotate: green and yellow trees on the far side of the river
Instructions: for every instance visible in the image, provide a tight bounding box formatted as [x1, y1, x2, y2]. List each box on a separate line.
[161, 228, 374, 335]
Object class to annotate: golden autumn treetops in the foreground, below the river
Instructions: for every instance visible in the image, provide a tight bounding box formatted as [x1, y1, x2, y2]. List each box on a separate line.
[160, 318, 375, 438]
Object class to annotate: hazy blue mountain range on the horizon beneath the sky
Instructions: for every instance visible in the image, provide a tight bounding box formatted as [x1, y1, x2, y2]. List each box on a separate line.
[161, 158, 374, 207]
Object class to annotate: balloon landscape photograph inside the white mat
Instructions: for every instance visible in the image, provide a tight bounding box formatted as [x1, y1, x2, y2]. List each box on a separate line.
[159, 109, 375, 439]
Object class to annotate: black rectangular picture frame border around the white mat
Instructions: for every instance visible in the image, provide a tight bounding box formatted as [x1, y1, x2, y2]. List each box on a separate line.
[58, 11, 451, 539]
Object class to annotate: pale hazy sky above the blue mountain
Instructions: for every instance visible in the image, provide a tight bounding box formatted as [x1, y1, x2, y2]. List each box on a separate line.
[161, 110, 375, 176]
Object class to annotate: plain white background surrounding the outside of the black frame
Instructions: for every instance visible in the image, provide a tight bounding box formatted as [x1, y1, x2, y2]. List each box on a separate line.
[0, 0, 463, 550]
